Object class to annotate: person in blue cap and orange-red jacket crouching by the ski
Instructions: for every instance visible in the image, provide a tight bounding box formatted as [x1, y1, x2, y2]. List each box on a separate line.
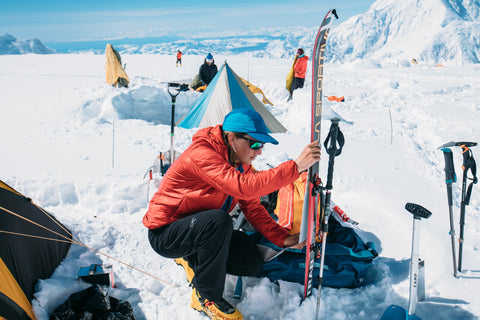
[143, 109, 320, 319]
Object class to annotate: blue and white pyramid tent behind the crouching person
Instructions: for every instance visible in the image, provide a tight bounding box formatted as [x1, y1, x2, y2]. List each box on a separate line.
[177, 62, 287, 133]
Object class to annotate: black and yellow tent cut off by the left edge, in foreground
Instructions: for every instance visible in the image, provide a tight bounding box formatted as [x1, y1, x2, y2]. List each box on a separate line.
[0, 180, 72, 320]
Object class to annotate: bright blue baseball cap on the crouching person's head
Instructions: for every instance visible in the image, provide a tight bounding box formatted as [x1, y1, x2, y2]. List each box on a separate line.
[223, 109, 278, 144]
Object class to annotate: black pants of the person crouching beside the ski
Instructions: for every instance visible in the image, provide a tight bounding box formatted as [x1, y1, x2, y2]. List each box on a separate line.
[148, 210, 263, 302]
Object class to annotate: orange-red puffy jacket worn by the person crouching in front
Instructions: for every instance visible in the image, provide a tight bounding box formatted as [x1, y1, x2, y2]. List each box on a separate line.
[143, 125, 299, 247]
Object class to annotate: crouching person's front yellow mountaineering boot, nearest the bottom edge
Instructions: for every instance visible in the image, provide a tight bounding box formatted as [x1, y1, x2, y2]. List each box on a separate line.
[190, 288, 243, 320]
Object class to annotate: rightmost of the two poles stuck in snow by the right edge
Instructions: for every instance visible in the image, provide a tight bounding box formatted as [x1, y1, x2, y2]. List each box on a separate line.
[458, 142, 478, 272]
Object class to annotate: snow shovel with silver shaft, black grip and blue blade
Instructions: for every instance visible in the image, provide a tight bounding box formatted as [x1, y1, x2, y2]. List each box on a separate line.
[380, 203, 432, 320]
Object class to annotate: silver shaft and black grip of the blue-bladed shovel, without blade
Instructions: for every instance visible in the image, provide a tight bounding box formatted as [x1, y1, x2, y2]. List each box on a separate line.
[405, 203, 432, 316]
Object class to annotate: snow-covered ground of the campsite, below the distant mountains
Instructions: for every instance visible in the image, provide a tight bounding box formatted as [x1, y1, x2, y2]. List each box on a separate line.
[0, 54, 480, 320]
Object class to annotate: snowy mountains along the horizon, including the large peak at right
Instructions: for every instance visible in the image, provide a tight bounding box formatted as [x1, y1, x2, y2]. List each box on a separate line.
[0, 0, 480, 65]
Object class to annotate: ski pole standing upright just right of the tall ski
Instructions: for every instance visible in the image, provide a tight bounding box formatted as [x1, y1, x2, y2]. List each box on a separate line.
[315, 118, 345, 319]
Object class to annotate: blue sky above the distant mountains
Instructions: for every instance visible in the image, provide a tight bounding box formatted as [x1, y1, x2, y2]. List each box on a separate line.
[0, 0, 374, 42]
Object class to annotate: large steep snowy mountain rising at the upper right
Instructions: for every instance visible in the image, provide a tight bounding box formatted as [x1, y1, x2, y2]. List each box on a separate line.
[329, 0, 480, 64]
